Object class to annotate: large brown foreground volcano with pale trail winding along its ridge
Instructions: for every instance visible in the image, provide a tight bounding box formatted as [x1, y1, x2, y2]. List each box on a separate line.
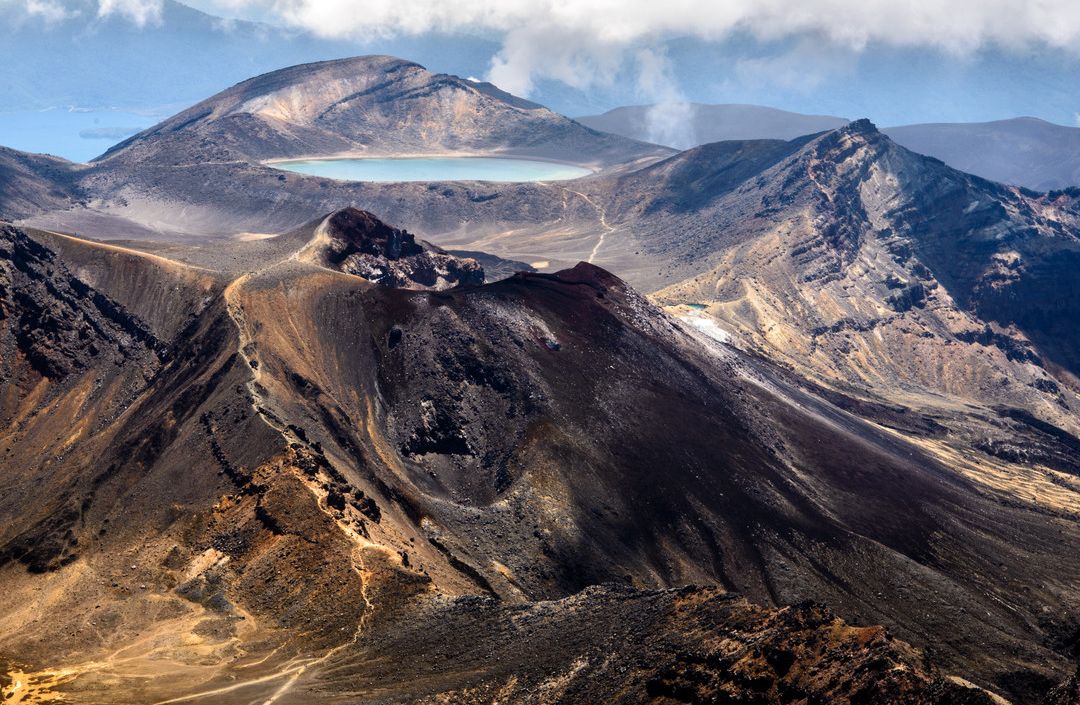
[0, 211, 1080, 703]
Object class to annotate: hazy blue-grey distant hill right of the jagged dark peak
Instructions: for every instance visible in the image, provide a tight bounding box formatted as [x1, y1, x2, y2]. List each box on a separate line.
[883, 118, 1080, 191]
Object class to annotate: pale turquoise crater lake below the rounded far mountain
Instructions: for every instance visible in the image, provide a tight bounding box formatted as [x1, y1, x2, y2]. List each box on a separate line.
[271, 157, 592, 181]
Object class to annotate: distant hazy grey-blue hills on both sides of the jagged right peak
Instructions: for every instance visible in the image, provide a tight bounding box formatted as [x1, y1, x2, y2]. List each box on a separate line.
[578, 104, 1080, 191]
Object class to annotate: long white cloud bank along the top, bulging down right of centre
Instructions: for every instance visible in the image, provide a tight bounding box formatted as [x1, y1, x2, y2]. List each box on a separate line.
[177, 0, 1080, 100]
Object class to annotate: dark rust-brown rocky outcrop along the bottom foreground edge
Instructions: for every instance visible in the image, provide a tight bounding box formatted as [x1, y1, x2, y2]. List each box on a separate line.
[316, 585, 996, 705]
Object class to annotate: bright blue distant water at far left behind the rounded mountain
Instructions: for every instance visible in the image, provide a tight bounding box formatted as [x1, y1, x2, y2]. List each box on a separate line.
[0, 108, 161, 162]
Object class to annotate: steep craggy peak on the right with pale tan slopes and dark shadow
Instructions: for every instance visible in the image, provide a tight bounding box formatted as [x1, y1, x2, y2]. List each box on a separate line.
[630, 121, 1080, 433]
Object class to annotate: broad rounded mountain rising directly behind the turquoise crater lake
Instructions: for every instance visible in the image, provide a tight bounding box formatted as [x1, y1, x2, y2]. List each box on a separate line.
[97, 56, 662, 165]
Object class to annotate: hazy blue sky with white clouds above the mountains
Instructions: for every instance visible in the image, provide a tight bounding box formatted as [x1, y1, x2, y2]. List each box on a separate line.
[0, 0, 1080, 125]
